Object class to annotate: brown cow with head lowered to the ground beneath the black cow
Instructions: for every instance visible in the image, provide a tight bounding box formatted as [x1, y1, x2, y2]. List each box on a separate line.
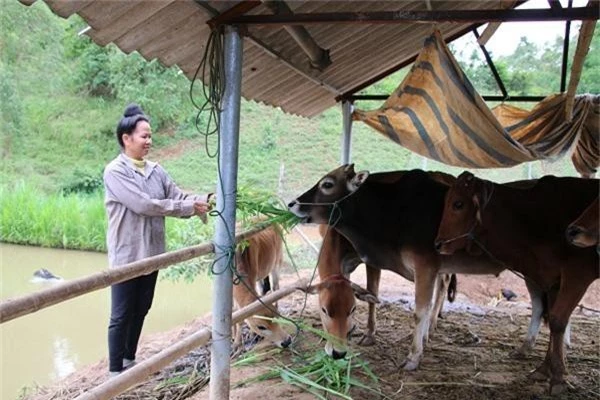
[307, 225, 456, 359]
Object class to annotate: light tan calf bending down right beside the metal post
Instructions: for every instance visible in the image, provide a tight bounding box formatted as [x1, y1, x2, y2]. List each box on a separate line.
[233, 225, 292, 348]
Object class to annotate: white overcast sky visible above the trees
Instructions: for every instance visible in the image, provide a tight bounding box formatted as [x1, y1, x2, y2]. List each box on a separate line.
[454, 0, 587, 56]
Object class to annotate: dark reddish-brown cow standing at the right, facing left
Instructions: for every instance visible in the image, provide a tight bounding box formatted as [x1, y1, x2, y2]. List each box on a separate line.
[435, 172, 600, 394]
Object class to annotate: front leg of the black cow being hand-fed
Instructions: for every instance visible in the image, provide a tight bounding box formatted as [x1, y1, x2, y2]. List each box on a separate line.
[403, 262, 437, 371]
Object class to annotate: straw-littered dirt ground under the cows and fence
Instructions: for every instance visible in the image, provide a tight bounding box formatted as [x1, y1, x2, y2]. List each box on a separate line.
[27, 228, 600, 400]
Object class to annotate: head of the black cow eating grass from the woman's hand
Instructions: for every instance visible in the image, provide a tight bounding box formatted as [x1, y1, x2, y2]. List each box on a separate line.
[288, 164, 369, 224]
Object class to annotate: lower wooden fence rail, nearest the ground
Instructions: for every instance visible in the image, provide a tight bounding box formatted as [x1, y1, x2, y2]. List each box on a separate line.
[76, 279, 306, 400]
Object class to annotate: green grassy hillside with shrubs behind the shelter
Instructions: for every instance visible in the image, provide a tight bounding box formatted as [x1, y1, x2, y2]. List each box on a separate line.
[0, 1, 600, 249]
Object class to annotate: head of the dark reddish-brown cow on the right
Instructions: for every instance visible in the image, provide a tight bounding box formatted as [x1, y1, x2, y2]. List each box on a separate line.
[435, 172, 493, 254]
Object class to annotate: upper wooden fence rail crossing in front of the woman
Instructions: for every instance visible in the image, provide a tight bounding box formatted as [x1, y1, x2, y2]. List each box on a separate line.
[0, 225, 268, 324]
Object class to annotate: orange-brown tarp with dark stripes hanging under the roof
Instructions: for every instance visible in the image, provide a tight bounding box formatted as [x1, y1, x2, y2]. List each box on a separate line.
[353, 31, 600, 176]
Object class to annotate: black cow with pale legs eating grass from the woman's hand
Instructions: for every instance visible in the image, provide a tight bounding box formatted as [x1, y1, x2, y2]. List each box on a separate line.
[288, 164, 572, 370]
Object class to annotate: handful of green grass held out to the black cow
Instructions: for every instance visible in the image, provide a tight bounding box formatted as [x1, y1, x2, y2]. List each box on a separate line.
[237, 187, 301, 231]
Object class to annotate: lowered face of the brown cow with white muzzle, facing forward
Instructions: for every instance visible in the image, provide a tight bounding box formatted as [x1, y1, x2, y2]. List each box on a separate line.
[306, 275, 379, 359]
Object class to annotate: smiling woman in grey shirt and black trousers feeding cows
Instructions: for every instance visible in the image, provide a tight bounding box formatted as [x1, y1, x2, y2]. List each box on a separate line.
[104, 104, 211, 376]
